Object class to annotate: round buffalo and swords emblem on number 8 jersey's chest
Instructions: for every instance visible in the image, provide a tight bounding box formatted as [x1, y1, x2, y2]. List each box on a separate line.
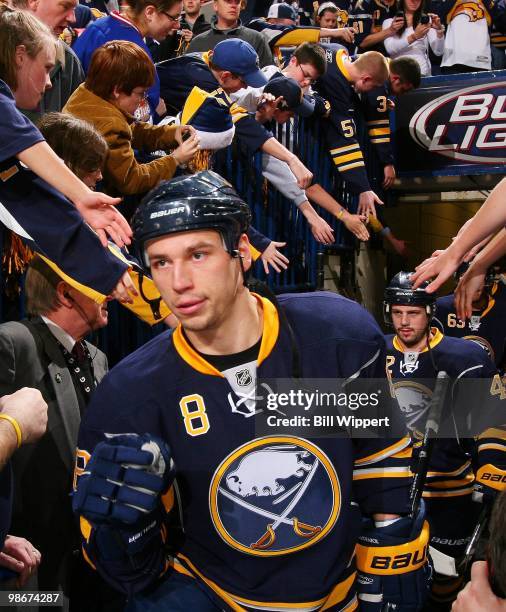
[209, 436, 341, 557]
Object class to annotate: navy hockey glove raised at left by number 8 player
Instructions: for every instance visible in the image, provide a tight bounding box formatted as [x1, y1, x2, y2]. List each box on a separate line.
[72, 434, 174, 525]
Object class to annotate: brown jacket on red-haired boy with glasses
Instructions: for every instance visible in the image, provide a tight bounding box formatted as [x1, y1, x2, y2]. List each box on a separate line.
[63, 84, 177, 195]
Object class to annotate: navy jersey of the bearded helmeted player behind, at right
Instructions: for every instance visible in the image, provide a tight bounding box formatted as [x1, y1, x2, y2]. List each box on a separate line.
[387, 328, 506, 557]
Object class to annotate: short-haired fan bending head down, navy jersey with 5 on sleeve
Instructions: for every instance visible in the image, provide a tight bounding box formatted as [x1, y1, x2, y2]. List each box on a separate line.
[315, 45, 388, 216]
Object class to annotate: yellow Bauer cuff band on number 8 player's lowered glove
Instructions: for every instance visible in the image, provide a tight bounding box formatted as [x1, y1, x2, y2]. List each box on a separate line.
[355, 521, 429, 576]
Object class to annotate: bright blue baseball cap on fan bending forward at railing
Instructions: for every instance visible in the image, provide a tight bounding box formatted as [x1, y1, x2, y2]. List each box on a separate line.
[212, 38, 267, 87]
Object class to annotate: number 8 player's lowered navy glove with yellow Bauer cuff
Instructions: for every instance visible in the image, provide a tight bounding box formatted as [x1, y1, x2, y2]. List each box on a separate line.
[356, 504, 432, 612]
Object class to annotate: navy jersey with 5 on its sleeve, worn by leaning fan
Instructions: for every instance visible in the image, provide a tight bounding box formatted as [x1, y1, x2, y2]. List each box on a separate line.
[315, 45, 370, 193]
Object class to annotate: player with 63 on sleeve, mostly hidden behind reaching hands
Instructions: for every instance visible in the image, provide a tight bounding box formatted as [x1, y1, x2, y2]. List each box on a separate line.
[434, 263, 506, 370]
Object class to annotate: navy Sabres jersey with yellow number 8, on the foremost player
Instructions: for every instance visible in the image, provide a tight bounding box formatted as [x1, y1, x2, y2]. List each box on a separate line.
[76, 293, 411, 610]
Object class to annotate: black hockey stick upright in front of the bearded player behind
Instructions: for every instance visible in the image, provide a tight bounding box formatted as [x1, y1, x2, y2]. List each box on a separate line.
[409, 371, 450, 518]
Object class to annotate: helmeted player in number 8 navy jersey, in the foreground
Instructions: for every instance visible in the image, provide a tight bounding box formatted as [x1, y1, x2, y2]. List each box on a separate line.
[74, 172, 428, 612]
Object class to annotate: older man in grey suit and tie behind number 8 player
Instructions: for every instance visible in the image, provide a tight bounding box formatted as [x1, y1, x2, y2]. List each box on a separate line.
[0, 257, 121, 610]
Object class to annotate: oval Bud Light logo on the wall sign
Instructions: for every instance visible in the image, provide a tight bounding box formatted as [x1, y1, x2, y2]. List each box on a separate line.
[409, 80, 506, 164]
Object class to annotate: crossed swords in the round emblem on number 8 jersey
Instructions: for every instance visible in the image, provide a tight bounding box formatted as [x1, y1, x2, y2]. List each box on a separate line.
[218, 459, 322, 550]
